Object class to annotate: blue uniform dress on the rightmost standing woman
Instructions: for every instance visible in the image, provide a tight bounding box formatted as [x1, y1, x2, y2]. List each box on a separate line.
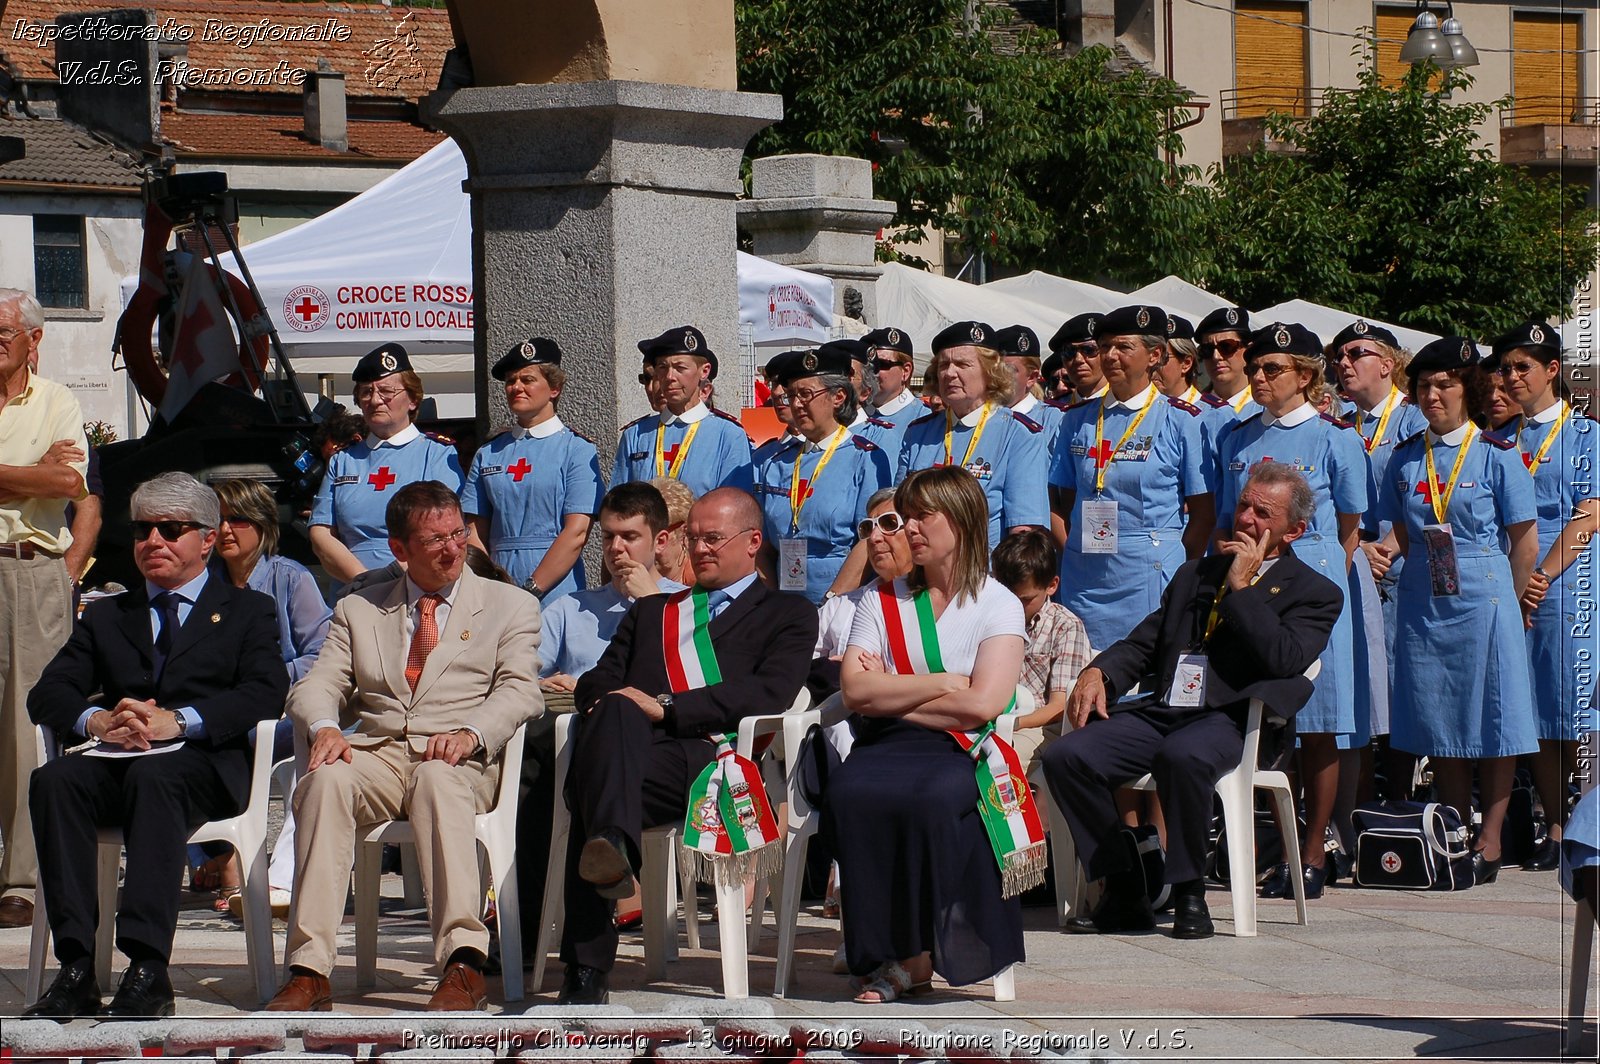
[1507, 402, 1600, 739]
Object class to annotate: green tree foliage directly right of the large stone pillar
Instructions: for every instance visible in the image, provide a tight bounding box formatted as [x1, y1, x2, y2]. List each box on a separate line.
[736, 0, 1200, 285]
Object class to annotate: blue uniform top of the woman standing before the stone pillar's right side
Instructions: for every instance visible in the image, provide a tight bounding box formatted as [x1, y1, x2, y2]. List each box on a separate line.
[611, 403, 755, 499]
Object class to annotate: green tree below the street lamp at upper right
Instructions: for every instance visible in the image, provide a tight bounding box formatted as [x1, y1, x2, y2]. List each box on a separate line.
[1197, 56, 1597, 336]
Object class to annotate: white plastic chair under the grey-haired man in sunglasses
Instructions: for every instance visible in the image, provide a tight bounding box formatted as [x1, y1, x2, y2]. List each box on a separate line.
[26, 718, 278, 1002]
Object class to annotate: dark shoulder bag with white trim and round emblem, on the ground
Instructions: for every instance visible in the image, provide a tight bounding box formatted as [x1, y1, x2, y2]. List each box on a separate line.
[1352, 802, 1472, 890]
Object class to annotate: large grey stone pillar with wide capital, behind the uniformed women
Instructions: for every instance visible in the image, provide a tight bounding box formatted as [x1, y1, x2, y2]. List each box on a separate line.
[427, 80, 782, 472]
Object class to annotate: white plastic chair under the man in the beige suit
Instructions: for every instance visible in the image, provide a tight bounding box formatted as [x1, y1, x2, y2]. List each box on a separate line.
[355, 723, 528, 1002]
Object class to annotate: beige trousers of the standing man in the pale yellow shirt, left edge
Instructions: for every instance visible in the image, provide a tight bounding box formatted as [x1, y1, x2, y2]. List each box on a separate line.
[0, 555, 72, 901]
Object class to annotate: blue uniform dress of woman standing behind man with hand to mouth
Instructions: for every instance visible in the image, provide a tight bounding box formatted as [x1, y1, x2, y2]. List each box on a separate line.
[1216, 403, 1373, 750]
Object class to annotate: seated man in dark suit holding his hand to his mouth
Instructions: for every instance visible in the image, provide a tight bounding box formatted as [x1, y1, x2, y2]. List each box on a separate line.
[1043, 462, 1344, 938]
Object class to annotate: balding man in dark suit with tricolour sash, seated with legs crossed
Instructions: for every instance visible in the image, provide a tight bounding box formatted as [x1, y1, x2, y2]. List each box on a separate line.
[560, 488, 816, 1005]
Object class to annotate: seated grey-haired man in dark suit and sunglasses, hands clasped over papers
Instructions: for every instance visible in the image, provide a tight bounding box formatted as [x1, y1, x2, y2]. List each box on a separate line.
[24, 474, 288, 1022]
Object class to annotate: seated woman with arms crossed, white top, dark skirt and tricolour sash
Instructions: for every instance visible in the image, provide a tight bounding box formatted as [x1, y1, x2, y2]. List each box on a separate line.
[822, 466, 1045, 1003]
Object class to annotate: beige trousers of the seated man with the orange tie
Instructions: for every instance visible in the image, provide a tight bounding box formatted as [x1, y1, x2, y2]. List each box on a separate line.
[288, 738, 499, 974]
